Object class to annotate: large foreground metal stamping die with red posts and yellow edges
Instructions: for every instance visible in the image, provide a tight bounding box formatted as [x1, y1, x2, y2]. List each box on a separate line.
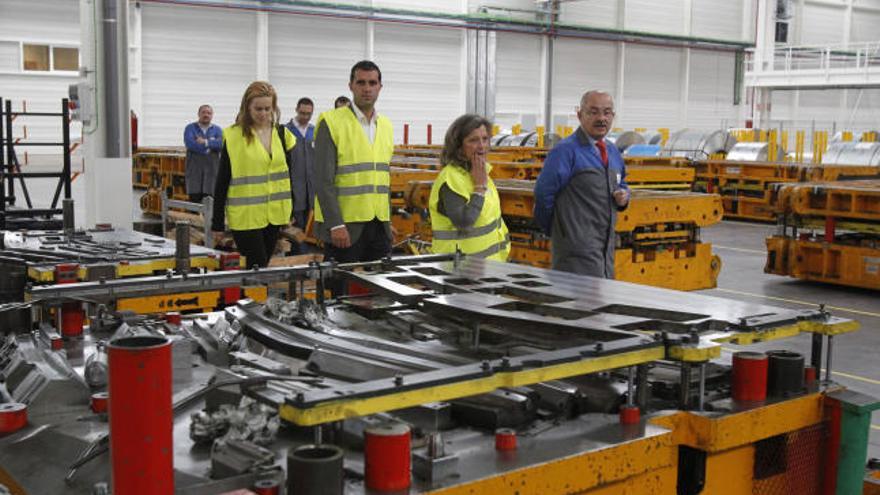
[0, 255, 878, 495]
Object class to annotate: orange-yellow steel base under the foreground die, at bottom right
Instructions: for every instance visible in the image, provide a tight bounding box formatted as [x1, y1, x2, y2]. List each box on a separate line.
[431, 393, 832, 495]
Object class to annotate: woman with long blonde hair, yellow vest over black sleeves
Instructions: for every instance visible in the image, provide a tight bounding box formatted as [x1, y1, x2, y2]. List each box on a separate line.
[211, 81, 296, 266]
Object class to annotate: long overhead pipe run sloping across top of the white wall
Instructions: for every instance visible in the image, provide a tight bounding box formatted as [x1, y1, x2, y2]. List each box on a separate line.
[140, 0, 754, 52]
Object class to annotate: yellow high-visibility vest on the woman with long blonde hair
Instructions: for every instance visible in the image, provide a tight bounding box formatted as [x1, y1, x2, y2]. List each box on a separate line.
[223, 125, 296, 230]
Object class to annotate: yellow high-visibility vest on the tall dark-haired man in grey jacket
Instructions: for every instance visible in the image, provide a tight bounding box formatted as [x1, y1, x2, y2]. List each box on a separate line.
[315, 107, 394, 227]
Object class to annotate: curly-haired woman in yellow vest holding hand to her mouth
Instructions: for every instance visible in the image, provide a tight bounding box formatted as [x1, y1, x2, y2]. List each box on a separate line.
[429, 114, 510, 261]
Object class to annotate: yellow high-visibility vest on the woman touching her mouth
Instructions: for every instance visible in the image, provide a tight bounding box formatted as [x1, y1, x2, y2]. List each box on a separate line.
[429, 163, 510, 261]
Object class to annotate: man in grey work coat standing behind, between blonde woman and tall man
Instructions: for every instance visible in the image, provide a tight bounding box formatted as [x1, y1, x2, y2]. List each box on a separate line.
[287, 98, 315, 254]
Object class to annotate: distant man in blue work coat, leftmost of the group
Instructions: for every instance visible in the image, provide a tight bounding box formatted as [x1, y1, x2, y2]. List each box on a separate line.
[183, 105, 223, 203]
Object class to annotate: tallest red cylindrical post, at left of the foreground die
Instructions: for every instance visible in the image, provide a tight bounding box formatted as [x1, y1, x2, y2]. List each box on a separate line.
[108, 336, 174, 495]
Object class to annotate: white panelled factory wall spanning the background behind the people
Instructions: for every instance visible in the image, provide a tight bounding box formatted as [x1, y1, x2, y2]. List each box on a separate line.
[0, 0, 880, 149]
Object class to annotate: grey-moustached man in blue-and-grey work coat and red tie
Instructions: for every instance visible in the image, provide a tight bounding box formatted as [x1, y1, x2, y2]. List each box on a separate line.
[534, 91, 629, 278]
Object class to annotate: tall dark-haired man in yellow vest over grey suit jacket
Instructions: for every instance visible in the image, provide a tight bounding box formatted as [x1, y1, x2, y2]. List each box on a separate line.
[314, 60, 394, 263]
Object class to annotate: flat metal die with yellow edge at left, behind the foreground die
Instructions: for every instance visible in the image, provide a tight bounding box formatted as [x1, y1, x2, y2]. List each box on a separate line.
[0, 228, 245, 284]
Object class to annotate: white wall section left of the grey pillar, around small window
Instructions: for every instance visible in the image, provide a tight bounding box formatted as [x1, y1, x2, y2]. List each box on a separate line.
[0, 0, 81, 165]
